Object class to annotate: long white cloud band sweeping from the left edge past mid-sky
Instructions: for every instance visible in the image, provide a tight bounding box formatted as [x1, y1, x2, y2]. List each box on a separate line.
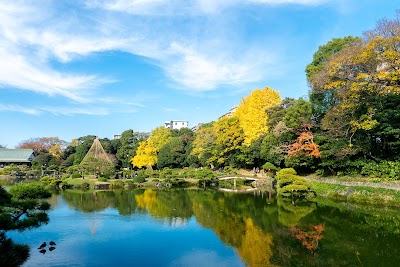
[0, 0, 322, 102]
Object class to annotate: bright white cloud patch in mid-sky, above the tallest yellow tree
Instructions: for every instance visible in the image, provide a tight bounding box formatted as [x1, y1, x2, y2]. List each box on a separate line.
[164, 43, 273, 91]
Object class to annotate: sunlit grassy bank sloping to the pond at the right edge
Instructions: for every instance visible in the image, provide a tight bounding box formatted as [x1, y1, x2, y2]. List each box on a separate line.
[311, 181, 400, 207]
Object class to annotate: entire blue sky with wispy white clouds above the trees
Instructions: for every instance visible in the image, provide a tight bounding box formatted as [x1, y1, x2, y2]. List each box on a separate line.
[0, 0, 400, 148]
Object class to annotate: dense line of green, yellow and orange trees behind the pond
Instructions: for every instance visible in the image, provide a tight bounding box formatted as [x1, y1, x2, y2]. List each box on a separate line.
[14, 12, 400, 178]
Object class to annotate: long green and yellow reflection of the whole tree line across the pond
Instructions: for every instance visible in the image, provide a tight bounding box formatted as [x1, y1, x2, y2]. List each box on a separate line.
[59, 190, 400, 266]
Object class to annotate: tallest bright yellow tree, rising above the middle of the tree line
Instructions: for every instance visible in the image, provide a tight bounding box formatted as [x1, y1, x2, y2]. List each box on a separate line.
[234, 87, 282, 146]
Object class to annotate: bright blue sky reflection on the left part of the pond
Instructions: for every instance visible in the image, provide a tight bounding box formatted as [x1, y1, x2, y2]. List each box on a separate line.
[7, 196, 244, 267]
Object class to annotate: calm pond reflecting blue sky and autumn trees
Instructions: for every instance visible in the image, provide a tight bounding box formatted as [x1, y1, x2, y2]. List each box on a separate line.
[7, 189, 400, 267]
